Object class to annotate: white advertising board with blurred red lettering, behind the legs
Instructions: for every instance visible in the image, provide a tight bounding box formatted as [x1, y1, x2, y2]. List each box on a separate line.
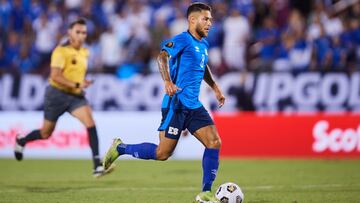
[0, 112, 204, 159]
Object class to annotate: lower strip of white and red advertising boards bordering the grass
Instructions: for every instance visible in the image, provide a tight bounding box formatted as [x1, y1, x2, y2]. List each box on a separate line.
[0, 112, 360, 159]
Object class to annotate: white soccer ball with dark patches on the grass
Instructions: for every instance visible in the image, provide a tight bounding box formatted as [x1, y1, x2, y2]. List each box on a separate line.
[215, 182, 244, 203]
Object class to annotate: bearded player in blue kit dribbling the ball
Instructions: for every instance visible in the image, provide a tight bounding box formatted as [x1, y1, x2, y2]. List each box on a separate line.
[103, 3, 225, 202]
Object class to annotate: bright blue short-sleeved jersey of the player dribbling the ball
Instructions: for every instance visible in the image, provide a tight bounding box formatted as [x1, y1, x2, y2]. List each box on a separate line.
[162, 32, 209, 109]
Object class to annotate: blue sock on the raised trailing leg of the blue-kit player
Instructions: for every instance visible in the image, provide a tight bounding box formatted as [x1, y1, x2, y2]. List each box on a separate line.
[117, 143, 157, 160]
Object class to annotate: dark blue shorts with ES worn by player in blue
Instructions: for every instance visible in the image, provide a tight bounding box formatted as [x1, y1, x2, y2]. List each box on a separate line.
[158, 106, 214, 140]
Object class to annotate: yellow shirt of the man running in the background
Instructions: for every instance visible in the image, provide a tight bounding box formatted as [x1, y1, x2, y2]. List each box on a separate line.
[49, 45, 89, 94]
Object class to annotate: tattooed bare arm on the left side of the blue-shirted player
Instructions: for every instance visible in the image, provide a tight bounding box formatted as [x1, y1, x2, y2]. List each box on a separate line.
[157, 51, 180, 96]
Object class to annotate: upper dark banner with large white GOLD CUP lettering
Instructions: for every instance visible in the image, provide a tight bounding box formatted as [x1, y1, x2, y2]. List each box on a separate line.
[0, 72, 360, 112]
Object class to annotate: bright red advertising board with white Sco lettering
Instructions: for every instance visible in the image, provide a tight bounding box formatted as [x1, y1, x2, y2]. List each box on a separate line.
[214, 113, 360, 158]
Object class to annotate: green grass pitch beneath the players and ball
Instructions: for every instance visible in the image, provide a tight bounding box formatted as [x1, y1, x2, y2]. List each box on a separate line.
[0, 159, 360, 203]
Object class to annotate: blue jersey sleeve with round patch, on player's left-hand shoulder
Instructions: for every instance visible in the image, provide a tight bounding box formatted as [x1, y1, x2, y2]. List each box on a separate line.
[161, 34, 189, 58]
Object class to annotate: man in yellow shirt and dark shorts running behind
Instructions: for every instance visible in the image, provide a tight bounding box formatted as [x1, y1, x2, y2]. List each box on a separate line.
[15, 18, 108, 177]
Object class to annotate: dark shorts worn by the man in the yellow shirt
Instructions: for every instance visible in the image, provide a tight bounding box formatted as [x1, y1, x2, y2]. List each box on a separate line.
[44, 85, 88, 122]
